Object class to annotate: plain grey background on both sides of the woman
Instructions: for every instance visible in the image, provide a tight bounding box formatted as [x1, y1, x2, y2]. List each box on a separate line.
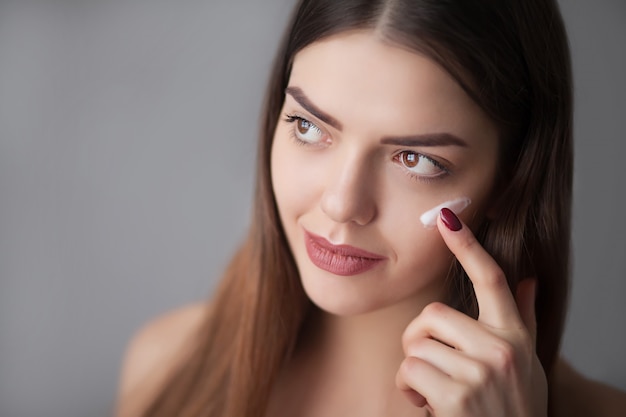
[0, 0, 626, 417]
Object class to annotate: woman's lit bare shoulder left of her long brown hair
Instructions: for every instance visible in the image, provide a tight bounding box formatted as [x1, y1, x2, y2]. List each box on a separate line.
[116, 304, 208, 417]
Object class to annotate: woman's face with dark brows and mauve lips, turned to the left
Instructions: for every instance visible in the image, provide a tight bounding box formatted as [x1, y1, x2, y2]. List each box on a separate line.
[271, 32, 498, 315]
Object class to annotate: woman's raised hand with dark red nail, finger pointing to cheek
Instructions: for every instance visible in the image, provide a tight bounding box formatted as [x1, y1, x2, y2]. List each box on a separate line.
[396, 209, 547, 417]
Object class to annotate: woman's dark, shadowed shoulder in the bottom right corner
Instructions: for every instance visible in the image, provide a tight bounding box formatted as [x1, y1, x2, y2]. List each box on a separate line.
[552, 359, 626, 417]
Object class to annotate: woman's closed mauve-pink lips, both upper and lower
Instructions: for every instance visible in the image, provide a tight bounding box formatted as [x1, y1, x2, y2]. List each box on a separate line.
[304, 231, 386, 276]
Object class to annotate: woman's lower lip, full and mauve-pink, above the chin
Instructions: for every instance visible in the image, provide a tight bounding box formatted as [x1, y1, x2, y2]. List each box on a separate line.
[304, 233, 384, 276]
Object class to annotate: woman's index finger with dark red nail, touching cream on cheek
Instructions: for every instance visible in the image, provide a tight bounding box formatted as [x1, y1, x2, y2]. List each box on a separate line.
[437, 208, 522, 328]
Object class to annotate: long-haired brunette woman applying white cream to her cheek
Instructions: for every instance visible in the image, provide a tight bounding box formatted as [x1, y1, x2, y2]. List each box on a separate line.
[114, 0, 624, 417]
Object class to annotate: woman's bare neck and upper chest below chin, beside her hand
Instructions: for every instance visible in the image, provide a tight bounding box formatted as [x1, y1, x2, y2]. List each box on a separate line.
[268, 293, 440, 417]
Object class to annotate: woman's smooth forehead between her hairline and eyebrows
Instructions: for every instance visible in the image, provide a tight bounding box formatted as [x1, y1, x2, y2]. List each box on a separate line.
[289, 31, 495, 141]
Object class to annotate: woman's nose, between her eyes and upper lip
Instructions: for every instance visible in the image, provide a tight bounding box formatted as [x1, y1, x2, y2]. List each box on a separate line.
[320, 151, 377, 226]
